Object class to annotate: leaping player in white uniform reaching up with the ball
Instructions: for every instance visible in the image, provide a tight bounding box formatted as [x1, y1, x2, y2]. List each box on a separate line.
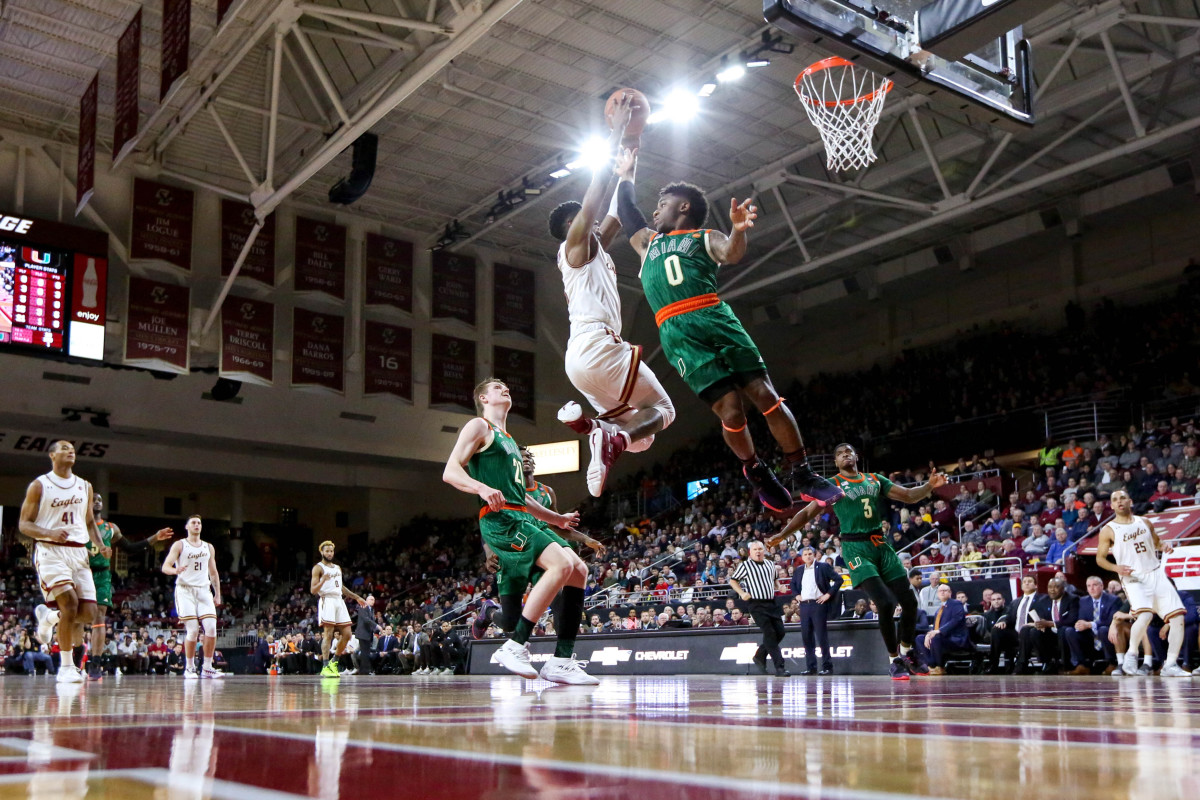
[550, 96, 674, 497]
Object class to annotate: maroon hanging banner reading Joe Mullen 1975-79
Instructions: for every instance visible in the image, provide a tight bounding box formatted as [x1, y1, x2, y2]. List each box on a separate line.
[125, 277, 191, 375]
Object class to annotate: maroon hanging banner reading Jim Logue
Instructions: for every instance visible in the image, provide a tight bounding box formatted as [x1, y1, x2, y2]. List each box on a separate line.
[130, 178, 196, 271]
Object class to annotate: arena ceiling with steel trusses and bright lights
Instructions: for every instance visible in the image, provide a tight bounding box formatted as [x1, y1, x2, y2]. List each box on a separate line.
[0, 0, 1200, 302]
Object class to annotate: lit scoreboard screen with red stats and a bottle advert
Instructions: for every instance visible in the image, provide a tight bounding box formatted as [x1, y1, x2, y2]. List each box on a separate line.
[0, 215, 108, 361]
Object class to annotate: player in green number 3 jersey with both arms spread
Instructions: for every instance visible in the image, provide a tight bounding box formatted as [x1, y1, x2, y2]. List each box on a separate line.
[767, 444, 946, 680]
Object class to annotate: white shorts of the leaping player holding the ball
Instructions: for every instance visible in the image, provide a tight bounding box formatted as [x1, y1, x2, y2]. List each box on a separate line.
[566, 326, 674, 452]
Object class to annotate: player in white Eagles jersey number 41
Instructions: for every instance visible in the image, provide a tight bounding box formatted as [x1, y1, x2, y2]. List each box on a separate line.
[19, 439, 106, 684]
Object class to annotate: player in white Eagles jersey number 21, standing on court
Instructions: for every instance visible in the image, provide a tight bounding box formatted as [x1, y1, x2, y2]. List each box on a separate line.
[162, 515, 224, 679]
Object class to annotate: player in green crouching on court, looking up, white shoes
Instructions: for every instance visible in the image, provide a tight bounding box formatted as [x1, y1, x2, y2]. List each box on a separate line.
[442, 378, 599, 684]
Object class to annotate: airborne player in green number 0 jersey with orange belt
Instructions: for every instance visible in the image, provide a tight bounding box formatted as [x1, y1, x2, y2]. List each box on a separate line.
[614, 149, 841, 511]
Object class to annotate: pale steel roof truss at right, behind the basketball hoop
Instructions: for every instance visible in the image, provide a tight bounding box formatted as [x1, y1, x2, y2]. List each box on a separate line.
[709, 0, 1200, 300]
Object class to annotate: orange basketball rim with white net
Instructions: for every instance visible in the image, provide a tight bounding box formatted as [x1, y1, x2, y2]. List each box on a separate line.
[792, 56, 892, 169]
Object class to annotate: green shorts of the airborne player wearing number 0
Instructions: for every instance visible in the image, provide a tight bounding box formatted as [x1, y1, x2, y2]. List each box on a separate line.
[659, 302, 767, 395]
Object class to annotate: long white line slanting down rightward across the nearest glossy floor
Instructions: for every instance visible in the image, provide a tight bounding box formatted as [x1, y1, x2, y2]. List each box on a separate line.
[204, 724, 949, 800]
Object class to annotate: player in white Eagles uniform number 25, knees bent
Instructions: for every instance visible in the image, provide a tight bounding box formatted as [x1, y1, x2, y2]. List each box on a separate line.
[1096, 489, 1200, 678]
